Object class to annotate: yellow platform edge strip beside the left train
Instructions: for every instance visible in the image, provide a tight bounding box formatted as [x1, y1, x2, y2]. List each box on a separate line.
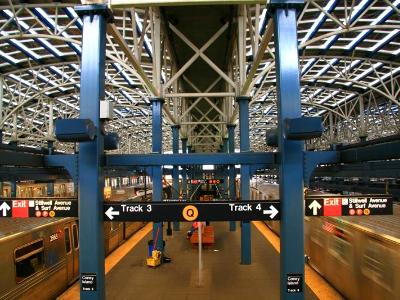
[57, 223, 153, 300]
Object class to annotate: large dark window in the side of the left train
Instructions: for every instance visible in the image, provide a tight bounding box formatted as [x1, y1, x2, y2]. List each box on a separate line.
[15, 240, 44, 283]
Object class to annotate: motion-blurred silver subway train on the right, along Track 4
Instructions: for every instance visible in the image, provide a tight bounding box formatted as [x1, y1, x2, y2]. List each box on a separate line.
[251, 184, 400, 300]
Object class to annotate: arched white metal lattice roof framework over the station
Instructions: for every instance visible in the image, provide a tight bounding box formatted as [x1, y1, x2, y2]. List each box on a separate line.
[0, 0, 400, 153]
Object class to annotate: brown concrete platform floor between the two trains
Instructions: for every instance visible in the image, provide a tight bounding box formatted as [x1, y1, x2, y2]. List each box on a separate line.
[106, 222, 317, 300]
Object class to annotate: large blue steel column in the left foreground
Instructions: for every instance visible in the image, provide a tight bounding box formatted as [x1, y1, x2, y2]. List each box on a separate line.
[75, 5, 110, 299]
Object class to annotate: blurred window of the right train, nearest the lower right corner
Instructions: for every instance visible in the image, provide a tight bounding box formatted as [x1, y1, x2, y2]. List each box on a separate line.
[361, 238, 394, 291]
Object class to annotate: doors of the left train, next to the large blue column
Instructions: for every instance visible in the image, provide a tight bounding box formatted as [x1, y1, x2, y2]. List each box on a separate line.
[64, 223, 79, 283]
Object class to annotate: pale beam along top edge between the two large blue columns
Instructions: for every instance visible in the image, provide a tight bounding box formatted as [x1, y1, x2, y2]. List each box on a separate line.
[109, 0, 266, 8]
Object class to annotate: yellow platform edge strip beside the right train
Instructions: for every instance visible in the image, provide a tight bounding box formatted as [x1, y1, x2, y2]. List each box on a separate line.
[252, 221, 343, 300]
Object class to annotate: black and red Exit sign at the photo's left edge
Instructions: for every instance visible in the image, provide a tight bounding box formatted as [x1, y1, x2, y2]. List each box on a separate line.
[0, 198, 78, 218]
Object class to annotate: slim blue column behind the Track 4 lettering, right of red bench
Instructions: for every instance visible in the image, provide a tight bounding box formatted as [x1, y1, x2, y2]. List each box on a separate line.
[236, 96, 251, 265]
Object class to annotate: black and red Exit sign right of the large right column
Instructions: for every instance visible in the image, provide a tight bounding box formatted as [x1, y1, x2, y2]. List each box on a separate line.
[305, 195, 393, 217]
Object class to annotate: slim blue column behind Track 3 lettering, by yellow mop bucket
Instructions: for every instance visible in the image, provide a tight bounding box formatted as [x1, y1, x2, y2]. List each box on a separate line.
[150, 98, 164, 251]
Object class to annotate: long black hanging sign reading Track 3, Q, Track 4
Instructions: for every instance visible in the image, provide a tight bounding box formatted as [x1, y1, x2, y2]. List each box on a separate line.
[104, 201, 280, 222]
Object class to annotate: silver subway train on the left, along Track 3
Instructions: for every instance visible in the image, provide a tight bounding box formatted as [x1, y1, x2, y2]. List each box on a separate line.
[0, 187, 159, 299]
